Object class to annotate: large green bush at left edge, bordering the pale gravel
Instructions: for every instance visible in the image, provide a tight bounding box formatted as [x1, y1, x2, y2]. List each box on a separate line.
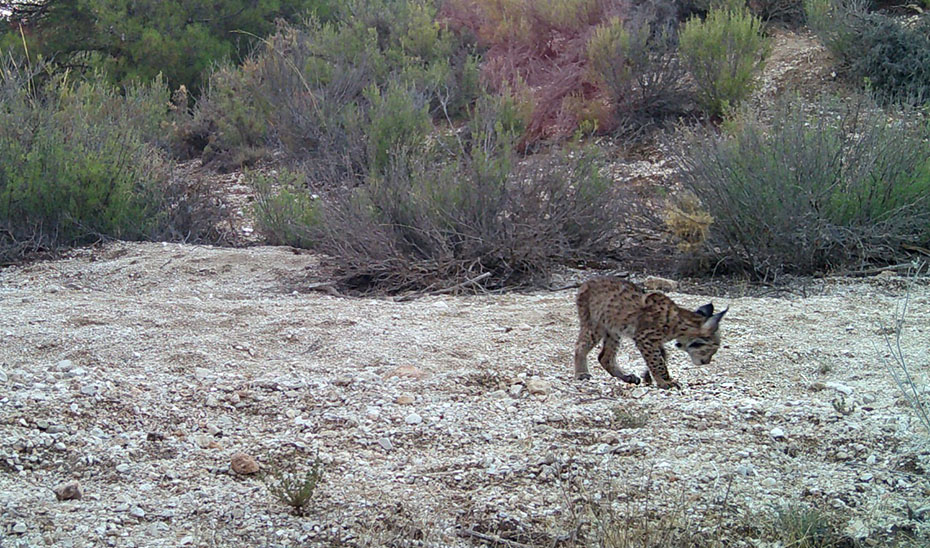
[0, 57, 221, 261]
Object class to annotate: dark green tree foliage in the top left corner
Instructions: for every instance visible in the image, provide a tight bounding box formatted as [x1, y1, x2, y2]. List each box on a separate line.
[0, 0, 331, 92]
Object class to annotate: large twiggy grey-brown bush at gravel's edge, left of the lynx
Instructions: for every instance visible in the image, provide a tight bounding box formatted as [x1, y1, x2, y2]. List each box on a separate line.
[298, 92, 633, 292]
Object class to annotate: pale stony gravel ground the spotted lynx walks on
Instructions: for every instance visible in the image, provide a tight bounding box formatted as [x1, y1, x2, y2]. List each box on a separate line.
[0, 243, 930, 547]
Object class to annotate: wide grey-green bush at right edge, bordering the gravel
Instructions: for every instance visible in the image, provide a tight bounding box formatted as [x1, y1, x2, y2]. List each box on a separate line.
[677, 96, 930, 276]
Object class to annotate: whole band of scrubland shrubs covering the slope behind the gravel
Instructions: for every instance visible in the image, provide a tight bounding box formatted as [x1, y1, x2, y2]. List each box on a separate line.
[0, 0, 930, 286]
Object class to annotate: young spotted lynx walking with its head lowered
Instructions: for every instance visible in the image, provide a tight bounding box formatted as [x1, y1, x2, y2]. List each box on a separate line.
[575, 278, 727, 388]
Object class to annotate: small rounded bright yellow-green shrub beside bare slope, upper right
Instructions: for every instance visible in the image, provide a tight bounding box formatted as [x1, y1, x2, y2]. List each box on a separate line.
[679, 8, 770, 116]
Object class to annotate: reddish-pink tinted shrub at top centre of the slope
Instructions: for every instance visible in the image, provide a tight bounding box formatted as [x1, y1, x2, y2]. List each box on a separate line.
[440, 0, 628, 146]
